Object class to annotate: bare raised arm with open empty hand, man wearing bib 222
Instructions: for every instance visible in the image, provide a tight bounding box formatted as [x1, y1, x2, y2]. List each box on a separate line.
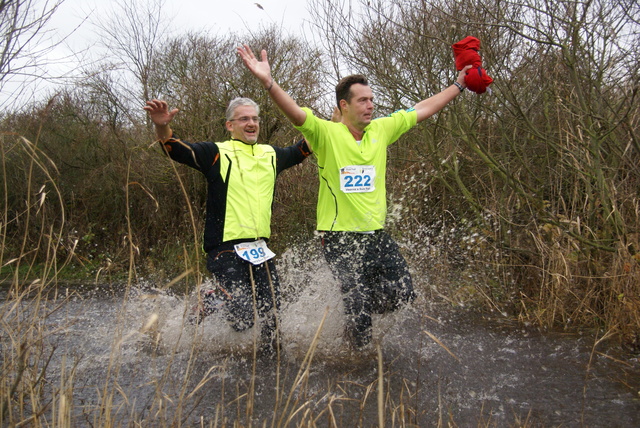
[238, 45, 307, 126]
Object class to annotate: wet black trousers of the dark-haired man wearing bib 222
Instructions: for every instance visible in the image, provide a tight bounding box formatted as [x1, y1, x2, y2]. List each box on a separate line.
[322, 230, 415, 346]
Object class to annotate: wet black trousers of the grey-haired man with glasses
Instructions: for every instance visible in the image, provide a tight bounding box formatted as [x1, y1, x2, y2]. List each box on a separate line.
[207, 250, 280, 344]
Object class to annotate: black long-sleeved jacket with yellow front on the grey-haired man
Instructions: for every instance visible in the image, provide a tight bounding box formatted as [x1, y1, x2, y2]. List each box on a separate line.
[161, 136, 310, 253]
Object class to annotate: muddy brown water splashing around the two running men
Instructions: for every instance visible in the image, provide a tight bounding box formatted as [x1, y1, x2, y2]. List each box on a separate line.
[12, 276, 640, 427]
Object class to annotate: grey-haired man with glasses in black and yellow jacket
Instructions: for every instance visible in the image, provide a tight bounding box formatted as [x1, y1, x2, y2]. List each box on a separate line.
[144, 98, 310, 353]
